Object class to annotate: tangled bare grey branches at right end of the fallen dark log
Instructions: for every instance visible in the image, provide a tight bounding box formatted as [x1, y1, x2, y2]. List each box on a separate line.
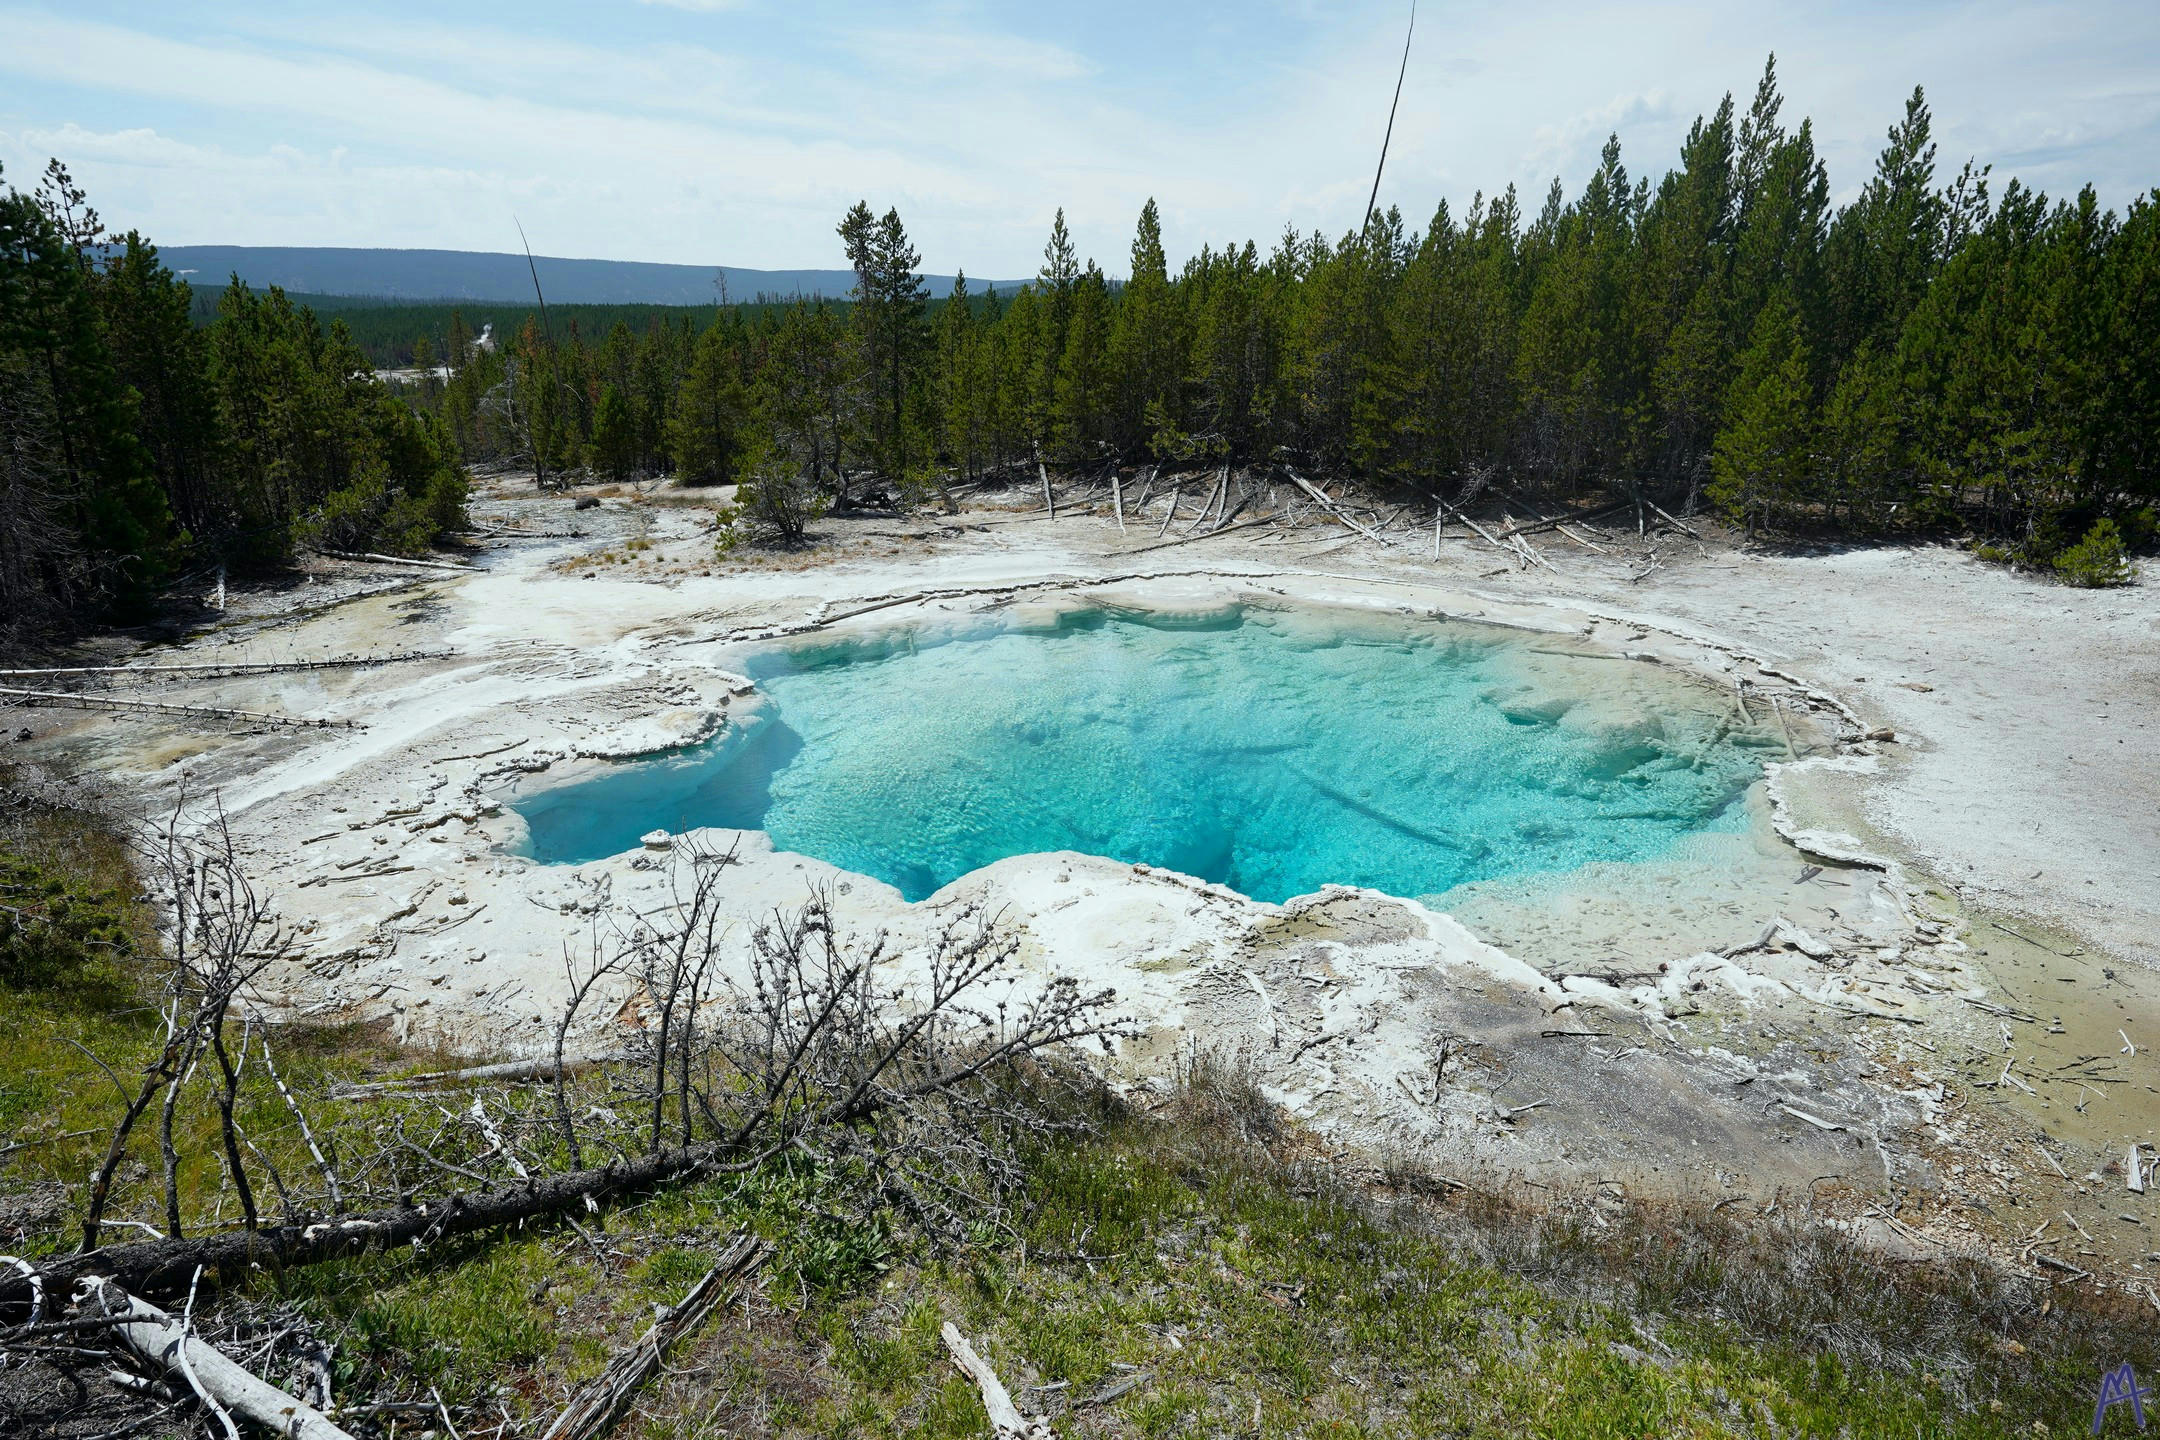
[591, 842, 1130, 1237]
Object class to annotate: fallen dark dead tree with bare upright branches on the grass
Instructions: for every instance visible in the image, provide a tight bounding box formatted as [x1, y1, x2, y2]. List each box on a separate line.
[0, 846, 1130, 1315]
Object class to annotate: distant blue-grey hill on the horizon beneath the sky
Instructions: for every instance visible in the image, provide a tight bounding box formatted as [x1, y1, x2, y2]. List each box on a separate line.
[158, 244, 1017, 304]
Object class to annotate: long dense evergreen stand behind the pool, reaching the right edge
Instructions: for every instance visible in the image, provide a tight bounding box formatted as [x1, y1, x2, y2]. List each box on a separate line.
[436, 63, 2160, 561]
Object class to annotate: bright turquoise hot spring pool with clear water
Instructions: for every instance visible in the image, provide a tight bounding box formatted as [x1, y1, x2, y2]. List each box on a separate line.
[514, 609, 1782, 900]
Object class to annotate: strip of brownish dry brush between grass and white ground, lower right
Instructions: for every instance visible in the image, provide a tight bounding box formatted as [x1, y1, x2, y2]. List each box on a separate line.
[1130, 1079, 2160, 1403]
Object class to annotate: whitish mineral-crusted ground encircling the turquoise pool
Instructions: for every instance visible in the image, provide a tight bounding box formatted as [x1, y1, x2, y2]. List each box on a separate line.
[11, 472, 2160, 1276]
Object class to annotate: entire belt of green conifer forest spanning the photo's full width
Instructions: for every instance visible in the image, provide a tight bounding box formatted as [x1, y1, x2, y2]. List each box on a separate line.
[0, 57, 2160, 643]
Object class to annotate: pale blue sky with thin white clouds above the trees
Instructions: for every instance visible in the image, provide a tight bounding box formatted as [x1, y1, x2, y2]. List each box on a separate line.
[0, 0, 2160, 279]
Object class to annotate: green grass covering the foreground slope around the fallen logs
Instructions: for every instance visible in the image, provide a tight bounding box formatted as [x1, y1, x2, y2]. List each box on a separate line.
[0, 781, 2160, 1440]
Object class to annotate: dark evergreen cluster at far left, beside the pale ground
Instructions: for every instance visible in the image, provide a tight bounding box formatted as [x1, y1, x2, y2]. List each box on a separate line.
[0, 162, 464, 639]
